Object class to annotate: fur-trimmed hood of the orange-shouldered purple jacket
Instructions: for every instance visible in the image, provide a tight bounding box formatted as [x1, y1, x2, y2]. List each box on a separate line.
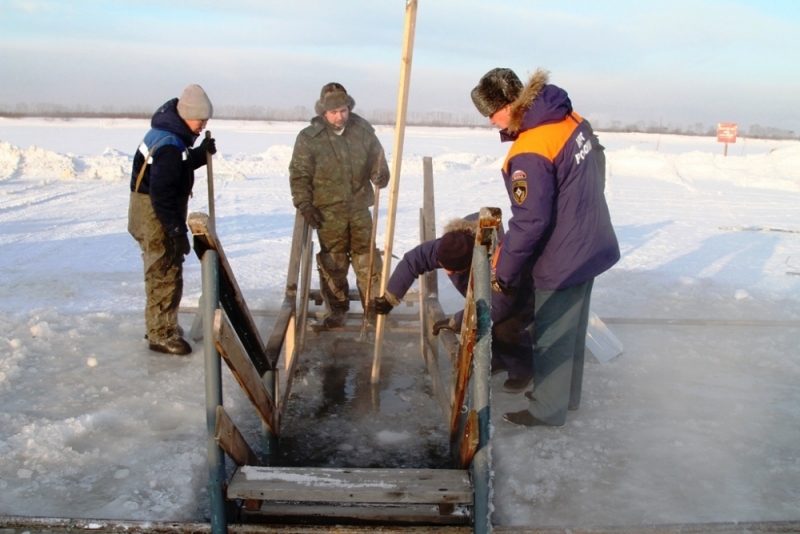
[506, 69, 572, 138]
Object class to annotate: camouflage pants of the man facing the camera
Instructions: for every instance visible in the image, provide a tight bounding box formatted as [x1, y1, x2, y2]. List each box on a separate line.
[317, 208, 383, 309]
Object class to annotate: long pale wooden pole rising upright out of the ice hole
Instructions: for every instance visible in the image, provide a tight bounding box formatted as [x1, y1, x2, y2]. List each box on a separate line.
[372, 0, 417, 384]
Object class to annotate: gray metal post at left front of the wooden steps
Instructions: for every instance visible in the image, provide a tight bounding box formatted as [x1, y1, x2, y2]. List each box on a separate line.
[201, 249, 228, 534]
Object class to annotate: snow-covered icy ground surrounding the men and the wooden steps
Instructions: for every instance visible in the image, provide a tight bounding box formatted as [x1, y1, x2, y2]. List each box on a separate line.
[0, 115, 800, 526]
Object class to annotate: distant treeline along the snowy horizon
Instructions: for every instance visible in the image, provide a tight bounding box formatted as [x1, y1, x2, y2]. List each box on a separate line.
[0, 103, 800, 139]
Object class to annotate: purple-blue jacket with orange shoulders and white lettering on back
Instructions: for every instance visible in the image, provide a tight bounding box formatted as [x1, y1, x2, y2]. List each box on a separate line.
[495, 71, 620, 290]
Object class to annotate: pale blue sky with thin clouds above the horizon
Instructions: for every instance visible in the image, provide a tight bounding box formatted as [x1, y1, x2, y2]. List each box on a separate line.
[0, 0, 800, 134]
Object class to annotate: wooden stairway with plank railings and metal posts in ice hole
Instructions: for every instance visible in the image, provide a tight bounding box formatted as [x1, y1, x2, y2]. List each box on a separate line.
[189, 158, 501, 534]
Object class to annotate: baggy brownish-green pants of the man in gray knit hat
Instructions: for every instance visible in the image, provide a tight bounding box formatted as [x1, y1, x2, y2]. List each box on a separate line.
[128, 193, 183, 341]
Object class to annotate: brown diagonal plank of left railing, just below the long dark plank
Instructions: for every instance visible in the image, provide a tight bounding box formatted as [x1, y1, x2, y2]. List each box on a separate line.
[214, 310, 280, 436]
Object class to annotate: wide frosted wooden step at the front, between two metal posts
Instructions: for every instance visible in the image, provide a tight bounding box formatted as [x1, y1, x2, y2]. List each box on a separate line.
[227, 466, 473, 525]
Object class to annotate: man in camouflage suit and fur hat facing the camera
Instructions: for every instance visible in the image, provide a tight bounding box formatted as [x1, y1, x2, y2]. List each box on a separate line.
[289, 83, 389, 328]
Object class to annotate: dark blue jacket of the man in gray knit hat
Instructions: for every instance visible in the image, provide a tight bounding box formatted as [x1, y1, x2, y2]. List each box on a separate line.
[131, 98, 206, 237]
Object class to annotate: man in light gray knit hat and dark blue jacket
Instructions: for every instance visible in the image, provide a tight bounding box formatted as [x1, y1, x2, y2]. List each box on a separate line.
[128, 84, 217, 355]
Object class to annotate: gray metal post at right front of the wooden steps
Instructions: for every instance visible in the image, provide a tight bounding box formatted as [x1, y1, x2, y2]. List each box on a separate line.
[470, 245, 492, 534]
